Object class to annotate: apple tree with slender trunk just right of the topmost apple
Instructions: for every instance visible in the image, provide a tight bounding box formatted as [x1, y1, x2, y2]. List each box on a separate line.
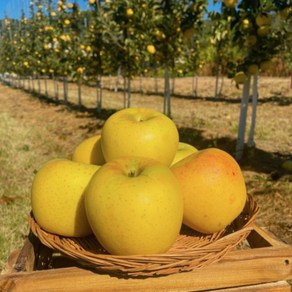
[148, 0, 207, 116]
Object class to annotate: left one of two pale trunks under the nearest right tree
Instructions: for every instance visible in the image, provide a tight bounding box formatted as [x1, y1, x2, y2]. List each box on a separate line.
[235, 77, 250, 160]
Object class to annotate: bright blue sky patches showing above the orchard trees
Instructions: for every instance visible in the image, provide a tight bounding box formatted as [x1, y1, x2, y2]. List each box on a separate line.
[0, 0, 219, 19]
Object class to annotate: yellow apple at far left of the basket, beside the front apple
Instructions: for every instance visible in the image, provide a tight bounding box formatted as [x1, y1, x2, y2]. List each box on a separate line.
[31, 159, 100, 237]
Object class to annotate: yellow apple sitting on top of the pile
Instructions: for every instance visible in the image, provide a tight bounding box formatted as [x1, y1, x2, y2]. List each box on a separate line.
[101, 108, 179, 166]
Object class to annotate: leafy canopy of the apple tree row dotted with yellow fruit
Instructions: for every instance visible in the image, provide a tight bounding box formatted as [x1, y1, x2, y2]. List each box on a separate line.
[0, 0, 292, 83]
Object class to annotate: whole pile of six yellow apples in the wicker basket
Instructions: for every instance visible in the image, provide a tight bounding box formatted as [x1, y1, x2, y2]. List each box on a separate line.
[31, 108, 247, 255]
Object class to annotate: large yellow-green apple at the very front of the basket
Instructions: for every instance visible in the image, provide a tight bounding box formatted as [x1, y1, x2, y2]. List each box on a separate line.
[85, 157, 183, 255]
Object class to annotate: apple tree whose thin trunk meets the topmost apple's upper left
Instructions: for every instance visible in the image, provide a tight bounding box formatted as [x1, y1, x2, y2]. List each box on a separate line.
[101, 0, 162, 107]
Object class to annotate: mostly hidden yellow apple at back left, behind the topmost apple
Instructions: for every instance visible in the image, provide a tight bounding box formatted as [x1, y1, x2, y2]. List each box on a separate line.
[72, 135, 105, 165]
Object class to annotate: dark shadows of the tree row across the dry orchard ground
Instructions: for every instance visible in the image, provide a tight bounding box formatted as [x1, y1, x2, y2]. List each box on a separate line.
[26, 88, 292, 179]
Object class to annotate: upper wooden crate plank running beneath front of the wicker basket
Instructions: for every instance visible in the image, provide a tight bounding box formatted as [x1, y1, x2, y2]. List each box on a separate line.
[0, 246, 292, 292]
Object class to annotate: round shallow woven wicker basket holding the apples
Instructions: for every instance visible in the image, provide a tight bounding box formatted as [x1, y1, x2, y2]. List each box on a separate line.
[29, 197, 258, 277]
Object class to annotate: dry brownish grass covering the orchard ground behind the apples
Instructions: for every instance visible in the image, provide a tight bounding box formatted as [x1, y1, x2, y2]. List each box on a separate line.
[0, 78, 292, 270]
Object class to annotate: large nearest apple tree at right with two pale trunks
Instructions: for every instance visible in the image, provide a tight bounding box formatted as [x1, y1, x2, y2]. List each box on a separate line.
[221, 0, 291, 159]
